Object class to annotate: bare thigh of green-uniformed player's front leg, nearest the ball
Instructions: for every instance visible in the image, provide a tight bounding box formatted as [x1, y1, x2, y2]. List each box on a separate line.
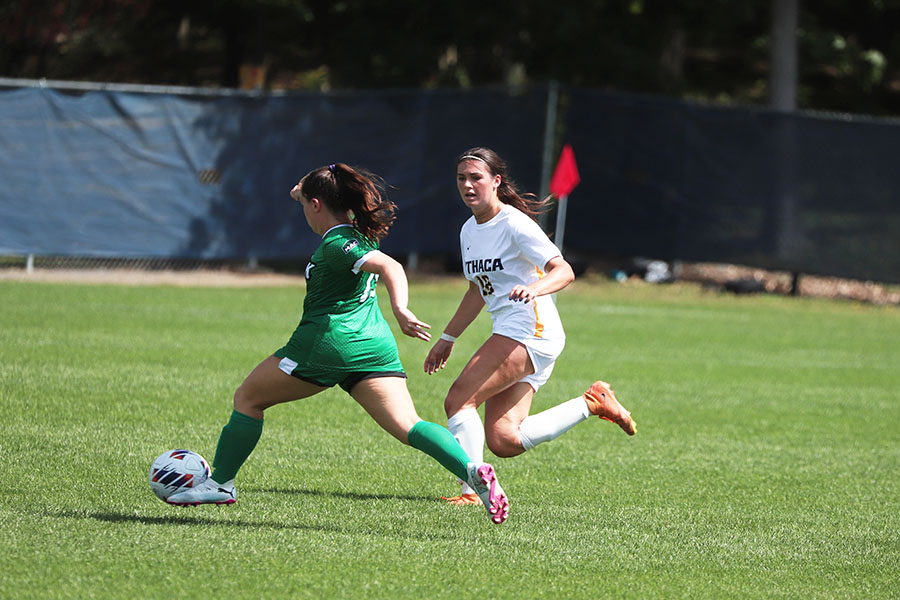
[234, 356, 326, 416]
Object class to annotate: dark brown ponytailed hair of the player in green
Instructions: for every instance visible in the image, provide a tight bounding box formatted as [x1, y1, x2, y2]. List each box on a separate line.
[300, 163, 397, 242]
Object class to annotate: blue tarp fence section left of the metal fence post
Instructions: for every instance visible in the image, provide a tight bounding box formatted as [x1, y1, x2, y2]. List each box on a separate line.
[0, 83, 546, 259]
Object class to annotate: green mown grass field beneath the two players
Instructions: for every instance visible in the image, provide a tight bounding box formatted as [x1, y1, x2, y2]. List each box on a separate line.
[0, 280, 900, 599]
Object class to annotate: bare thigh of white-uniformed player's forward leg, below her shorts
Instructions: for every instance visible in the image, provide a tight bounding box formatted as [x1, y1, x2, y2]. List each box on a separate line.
[445, 334, 534, 415]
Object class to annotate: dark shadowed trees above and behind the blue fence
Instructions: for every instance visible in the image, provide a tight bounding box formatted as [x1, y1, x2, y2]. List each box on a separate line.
[0, 0, 900, 115]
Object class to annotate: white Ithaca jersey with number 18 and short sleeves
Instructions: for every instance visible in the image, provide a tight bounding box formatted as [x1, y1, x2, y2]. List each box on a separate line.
[459, 204, 566, 356]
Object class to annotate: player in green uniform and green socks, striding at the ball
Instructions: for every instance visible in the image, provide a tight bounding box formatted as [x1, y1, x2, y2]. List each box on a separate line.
[167, 163, 509, 523]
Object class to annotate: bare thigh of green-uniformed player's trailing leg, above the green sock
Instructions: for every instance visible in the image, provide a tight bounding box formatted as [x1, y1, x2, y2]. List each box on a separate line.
[350, 376, 421, 444]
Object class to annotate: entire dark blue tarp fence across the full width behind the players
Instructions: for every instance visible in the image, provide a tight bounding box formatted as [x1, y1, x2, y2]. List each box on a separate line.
[0, 80, 900, 282]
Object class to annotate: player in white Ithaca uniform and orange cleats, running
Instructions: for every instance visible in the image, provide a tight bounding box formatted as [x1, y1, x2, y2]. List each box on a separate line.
[425, 148, 637, 504]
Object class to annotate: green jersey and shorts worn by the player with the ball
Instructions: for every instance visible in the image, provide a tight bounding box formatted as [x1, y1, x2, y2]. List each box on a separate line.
[275, 225, 403, 387]
